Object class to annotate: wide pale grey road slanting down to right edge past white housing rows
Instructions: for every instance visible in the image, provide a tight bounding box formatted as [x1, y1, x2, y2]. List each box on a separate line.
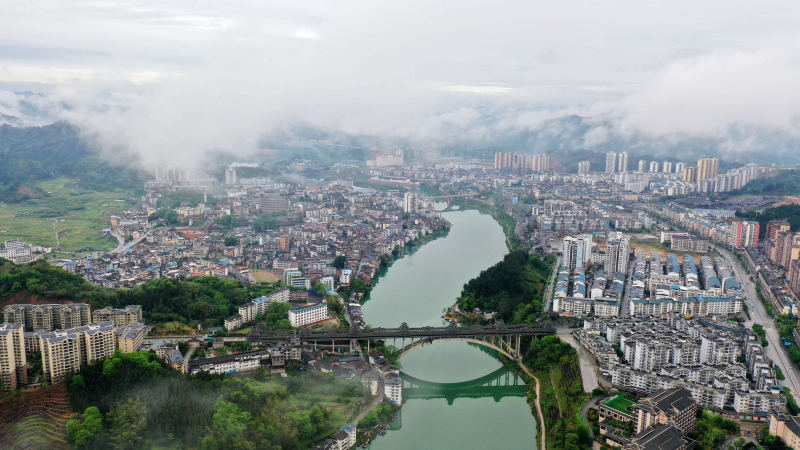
[714, 246, 800, 396]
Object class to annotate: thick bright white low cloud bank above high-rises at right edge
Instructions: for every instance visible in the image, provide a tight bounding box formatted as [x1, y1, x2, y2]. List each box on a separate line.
[620, 48, 800, 140]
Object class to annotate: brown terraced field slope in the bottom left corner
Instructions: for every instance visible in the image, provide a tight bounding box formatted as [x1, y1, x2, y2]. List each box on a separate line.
[0, 383, 73, 449]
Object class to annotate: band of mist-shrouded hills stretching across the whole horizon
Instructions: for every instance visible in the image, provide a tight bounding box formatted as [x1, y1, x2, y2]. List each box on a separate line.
[0, 91, 800, 192]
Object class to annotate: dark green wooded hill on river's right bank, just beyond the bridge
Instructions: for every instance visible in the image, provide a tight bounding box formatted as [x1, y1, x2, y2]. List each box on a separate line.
[458, 250, 554, 323]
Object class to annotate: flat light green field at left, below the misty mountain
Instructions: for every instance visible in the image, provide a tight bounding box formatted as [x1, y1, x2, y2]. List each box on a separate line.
[0, 177, 138, 253]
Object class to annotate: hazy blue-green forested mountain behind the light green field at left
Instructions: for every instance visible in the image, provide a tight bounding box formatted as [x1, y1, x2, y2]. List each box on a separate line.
[0, 122, 142, 202]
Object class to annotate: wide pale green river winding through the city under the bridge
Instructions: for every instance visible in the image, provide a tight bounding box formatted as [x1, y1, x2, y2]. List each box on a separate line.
[362, 210, 536, 450]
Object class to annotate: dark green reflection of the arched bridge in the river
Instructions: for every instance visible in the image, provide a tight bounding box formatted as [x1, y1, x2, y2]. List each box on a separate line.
[391, 367, 528, 430]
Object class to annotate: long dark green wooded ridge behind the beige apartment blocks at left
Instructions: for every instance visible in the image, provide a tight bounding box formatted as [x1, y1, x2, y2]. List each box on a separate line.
[0, 259, 274, 326]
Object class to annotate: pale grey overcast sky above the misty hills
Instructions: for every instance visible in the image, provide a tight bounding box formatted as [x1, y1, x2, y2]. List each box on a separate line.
[0, 0, 800, 165]
